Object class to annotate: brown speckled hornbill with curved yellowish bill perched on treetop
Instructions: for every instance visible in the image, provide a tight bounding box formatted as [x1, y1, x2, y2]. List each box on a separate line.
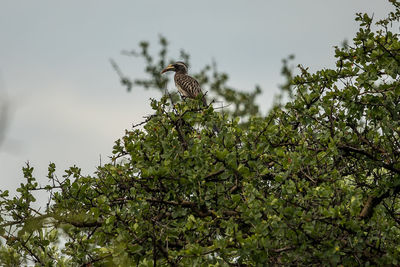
[161, 61, 207, 106]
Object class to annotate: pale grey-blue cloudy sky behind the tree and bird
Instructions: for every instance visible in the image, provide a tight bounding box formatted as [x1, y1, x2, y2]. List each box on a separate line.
[0, 0, 392, 197]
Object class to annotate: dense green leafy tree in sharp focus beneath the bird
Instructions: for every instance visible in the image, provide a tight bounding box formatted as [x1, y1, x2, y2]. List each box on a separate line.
[0, 1, 400, 266]
